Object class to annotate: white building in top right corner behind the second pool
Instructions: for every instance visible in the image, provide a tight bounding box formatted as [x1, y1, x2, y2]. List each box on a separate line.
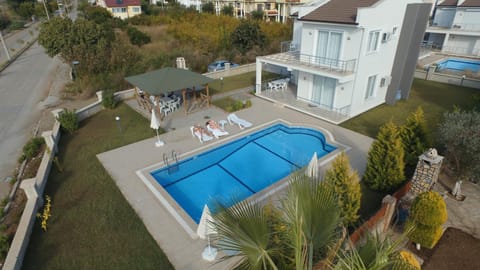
[424, 0, 480, 56]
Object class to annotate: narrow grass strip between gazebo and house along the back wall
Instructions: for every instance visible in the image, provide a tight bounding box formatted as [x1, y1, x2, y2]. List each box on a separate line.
[209, 71, 280, 95]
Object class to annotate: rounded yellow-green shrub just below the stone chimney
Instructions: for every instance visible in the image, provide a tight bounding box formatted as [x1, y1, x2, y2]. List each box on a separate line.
[406, 191, 447, 248]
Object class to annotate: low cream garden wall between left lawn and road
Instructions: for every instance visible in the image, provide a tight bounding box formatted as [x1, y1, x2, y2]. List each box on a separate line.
[2, 89, 134, 270]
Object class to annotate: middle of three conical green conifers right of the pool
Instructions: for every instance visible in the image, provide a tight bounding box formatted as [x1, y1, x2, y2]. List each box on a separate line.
[363, 121, 405, 191]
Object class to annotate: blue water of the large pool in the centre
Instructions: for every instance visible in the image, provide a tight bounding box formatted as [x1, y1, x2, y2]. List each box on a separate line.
[151, 124, 336, 224]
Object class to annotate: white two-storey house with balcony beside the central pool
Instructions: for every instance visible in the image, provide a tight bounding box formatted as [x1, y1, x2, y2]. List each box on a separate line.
[256, 0, 432, 123]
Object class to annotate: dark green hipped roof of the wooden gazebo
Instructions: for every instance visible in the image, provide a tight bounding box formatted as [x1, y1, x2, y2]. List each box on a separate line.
[125, 67, 213, 96]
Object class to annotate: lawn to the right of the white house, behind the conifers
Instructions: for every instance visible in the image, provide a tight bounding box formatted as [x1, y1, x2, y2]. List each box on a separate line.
[340, 79, 479, 138]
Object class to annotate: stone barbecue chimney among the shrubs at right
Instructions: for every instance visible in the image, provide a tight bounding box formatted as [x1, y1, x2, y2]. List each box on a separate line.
[409, 148, 443, 196]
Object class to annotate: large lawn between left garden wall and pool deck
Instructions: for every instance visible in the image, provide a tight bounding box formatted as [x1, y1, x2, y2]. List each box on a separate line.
[23, 104, 173, 270]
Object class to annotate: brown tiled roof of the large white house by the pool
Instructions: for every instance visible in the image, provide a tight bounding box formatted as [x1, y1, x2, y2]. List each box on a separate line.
[300, 0, 380, 24]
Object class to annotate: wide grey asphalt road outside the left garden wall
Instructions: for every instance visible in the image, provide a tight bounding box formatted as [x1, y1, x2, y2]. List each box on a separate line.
[0, 44, 58, 198]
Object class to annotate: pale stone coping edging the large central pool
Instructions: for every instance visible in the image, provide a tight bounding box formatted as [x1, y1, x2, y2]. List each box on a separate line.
[135, 118, 350, 239]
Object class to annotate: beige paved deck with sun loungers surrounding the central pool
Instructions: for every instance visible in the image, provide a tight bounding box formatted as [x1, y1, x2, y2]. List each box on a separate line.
[98, 97, 373, 269]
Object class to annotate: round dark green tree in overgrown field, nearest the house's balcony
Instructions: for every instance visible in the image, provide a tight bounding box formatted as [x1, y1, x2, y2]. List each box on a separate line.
[230, 20, 266, 53]
